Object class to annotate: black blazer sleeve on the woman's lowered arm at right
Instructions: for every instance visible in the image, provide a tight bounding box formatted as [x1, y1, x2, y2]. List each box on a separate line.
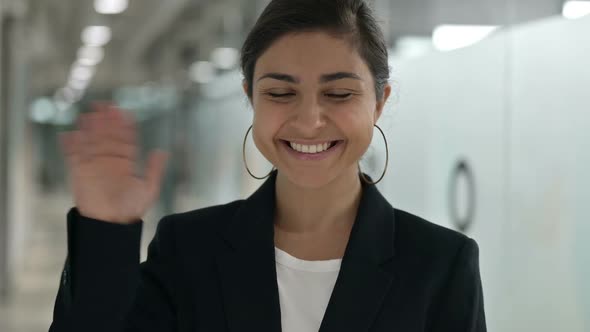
[432, 238, 486, 332]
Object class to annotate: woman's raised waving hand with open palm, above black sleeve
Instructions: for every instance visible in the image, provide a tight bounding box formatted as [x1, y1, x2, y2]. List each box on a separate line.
[61, 103, 167, 224]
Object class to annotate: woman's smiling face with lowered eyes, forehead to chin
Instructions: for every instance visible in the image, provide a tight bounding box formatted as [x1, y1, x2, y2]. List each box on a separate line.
[244, 32, 390, 188]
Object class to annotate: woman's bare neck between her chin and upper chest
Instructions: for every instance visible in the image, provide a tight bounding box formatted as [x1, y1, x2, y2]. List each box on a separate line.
[275, 167, 362, 234]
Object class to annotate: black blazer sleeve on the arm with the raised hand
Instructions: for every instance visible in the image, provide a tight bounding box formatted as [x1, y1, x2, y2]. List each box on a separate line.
[49, 208, 175, 332]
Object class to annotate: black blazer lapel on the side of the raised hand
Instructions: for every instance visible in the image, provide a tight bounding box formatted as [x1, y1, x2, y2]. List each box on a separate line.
[217, 171, 281, 332]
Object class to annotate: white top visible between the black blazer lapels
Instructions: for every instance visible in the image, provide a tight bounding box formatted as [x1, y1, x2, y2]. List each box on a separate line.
[275, 247, 342, 332]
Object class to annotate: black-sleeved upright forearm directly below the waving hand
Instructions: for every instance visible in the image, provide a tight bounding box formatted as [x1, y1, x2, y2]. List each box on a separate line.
[50, 209, 142, 332]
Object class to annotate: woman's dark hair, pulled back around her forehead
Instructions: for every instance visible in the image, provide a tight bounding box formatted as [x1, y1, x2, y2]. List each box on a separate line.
[241, 0, 389, 99]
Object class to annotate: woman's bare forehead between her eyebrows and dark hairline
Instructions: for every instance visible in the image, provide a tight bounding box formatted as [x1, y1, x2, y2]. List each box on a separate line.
[254, 32, 370, 78]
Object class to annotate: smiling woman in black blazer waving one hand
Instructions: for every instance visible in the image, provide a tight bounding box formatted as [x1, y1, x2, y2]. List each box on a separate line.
[50, 0, 486, 332]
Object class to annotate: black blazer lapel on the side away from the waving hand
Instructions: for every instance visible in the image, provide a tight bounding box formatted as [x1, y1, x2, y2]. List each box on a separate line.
[320, 178, 395, 332]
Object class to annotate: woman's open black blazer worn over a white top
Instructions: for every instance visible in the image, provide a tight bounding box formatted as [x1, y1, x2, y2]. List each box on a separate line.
[49, 171, 486, 332]
